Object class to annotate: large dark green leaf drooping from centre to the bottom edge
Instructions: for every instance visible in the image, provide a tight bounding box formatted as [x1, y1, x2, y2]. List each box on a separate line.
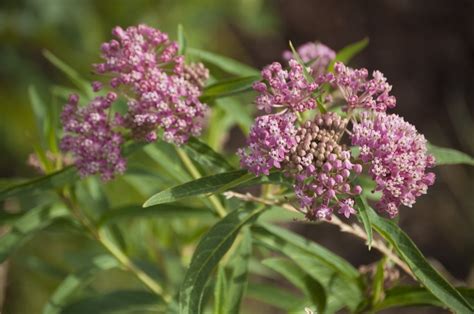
[179, 207, 263, 314]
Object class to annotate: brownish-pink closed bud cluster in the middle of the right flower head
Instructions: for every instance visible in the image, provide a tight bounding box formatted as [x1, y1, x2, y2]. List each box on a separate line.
[287, 112, 362, 220]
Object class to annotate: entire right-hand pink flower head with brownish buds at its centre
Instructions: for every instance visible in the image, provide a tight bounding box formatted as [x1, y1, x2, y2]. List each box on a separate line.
[239, 41, 435, 220]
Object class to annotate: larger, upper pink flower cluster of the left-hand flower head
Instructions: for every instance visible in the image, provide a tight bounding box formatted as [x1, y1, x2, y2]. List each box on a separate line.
[95, 25, 209, 144]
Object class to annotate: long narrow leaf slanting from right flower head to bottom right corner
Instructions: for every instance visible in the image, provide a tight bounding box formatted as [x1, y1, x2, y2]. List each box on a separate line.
[368, 207, 474, 313]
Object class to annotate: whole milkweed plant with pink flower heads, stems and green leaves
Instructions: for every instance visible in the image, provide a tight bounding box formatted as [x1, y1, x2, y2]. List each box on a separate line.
[0, 25, 474, 313]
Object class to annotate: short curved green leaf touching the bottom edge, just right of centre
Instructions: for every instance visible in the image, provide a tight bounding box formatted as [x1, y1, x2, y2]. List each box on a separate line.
[262, 258, 326, 313]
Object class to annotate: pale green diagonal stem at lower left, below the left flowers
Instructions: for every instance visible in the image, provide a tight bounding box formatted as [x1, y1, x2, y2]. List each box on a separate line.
[60, 193, 171, 303]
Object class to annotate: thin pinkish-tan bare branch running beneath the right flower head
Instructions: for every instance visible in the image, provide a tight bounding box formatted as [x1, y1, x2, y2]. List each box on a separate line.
[224, 191, 415, 279]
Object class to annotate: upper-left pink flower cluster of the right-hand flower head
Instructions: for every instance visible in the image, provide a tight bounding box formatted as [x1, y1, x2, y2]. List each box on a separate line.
[253, 59, 318, 113]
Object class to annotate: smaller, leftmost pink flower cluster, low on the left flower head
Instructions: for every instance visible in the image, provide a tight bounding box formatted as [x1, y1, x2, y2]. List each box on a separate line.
[61, 92, 126, 181]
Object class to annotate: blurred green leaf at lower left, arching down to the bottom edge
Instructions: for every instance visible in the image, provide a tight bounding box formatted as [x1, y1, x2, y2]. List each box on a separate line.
[43, 255, 119, 314]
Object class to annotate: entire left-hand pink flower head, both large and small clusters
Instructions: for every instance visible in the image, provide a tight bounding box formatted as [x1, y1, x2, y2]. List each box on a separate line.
[62, 25, 209, 180]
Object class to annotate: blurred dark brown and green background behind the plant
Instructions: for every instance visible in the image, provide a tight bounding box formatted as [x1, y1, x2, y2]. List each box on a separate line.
[0, 0, 474, 313]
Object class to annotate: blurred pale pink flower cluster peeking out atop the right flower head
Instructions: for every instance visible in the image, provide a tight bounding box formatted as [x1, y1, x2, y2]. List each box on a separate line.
[283, 42, 336, 78]
